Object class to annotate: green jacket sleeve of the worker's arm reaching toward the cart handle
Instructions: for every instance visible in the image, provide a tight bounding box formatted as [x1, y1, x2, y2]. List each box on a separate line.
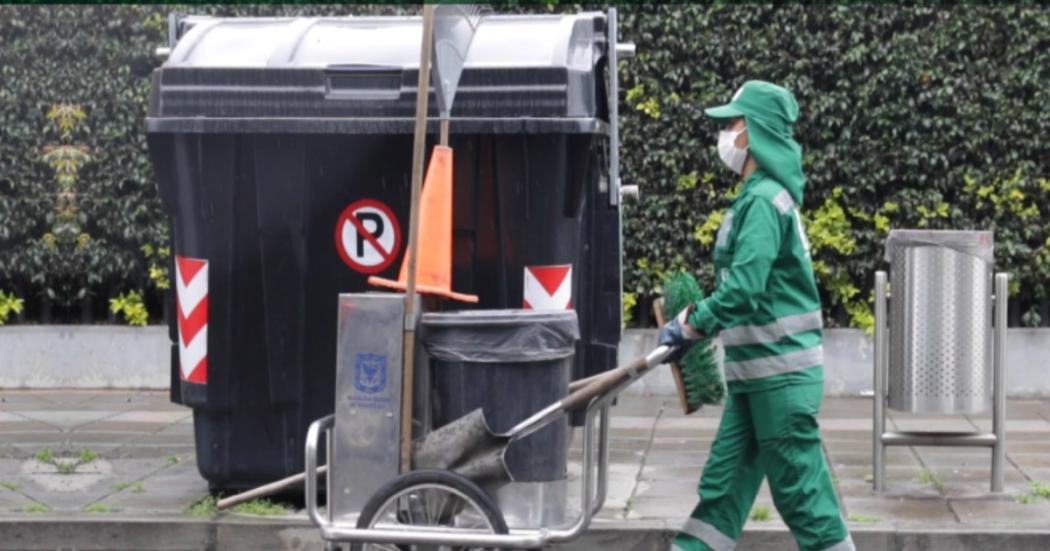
[689, 197, 783, 336]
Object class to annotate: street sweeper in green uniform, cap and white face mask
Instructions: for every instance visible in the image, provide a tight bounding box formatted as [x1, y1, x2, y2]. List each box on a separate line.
[660, 81, 855, 551]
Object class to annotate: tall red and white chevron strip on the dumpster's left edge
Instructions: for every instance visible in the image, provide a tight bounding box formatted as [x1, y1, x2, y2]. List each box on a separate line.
[175, 255, 208, 384]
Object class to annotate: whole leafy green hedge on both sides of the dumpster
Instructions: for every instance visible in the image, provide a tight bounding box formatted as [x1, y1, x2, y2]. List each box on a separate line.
[0, 5, 1050, 325]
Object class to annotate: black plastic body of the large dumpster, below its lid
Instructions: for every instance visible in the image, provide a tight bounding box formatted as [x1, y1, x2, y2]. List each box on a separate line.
[148, 132, 620, 489]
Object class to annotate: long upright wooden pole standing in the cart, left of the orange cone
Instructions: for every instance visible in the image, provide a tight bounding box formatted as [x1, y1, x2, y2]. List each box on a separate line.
[401, 4, 434, 472]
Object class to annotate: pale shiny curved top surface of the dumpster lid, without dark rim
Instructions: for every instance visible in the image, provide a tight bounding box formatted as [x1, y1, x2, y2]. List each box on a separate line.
[164, 13, 605, 70]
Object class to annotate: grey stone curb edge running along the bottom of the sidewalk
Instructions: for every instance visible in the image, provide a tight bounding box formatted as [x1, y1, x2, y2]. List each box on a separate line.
[0, 515, 1050, 551]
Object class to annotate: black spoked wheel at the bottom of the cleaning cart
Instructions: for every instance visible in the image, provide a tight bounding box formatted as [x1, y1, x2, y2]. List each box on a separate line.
[351, 470, 508, 551]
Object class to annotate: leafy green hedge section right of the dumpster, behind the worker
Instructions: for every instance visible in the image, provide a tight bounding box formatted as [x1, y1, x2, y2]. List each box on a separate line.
[622, 5, 1050, 326]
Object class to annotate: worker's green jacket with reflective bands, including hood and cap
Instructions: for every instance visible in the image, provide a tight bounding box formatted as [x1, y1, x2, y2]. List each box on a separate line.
[689, 81, 823, 394]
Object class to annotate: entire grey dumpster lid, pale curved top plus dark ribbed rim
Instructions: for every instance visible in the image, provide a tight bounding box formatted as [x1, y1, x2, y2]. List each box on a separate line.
[147, 13, 607, 133]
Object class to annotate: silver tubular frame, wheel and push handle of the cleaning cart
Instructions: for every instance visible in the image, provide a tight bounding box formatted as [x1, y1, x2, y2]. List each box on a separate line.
[306, 346, 672, 549]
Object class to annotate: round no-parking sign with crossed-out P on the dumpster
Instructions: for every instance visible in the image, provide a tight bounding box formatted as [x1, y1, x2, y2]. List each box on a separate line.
[335, 199, 401, 274]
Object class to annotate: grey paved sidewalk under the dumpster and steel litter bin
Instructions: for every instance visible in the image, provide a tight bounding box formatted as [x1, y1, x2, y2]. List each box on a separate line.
[0, 390, 1050, 551]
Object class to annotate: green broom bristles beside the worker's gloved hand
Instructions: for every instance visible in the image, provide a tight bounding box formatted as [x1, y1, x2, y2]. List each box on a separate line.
[664, 272, 726, 407]
